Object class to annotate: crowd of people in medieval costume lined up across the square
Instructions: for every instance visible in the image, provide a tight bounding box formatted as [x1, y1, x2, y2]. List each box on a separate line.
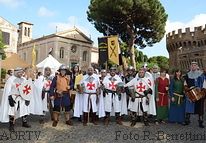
[0, 62, 206, 131]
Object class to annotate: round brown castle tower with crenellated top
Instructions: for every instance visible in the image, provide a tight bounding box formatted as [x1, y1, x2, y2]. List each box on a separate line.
[166, 25, 206, 71]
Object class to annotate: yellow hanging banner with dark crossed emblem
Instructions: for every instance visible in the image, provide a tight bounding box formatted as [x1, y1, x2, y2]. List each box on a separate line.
[107, 36, 120, 65]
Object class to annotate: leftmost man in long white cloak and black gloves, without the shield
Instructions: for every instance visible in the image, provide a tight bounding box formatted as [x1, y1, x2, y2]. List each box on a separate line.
[0, 68, 31, 131]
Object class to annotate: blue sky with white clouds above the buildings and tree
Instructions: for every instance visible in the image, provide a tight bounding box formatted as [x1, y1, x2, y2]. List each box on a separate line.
[0, 0, 206, 57]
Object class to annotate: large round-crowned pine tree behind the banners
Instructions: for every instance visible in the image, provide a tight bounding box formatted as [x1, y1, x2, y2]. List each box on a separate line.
[87, 0, 167, 67]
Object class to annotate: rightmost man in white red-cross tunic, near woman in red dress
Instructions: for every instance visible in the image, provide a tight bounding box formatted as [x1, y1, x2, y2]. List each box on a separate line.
[125, 68, 152, 127]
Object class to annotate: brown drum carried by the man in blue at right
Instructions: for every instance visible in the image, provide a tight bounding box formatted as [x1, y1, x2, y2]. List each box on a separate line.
[185, 86, 204, 102]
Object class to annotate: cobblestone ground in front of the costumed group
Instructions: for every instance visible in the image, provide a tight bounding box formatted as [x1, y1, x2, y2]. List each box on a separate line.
[0, 89, 206, 143]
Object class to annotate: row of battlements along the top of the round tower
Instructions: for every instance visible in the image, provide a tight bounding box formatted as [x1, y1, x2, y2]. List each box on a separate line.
[166, 24, 206, 39]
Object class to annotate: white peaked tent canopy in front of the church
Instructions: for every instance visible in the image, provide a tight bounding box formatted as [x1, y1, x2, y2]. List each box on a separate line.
[36, 55, 61, 74]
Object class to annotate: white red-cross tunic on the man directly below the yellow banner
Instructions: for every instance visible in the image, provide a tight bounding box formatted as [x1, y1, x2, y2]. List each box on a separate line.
[102, 75, 127, 115]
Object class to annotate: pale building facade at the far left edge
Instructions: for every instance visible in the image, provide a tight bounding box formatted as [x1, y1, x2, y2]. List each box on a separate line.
[0, 16, 18, 57]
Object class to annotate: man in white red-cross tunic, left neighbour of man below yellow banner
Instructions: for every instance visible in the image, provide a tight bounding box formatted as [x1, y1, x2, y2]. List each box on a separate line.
[80, 67, 100, 126]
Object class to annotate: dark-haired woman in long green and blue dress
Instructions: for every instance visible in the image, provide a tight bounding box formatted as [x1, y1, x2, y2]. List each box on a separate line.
[169, 69, 185, 123]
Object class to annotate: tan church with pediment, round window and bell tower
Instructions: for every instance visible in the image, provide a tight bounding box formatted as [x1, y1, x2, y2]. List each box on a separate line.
[17, 22, 97, 70]
